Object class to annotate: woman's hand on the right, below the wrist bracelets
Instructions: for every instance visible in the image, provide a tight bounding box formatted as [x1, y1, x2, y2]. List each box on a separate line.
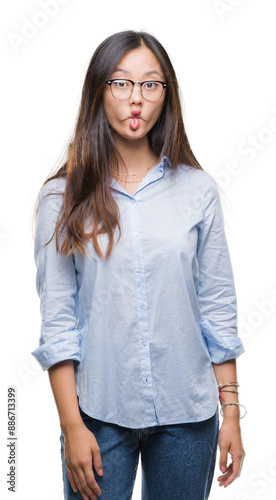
[218, 418, 245, 488]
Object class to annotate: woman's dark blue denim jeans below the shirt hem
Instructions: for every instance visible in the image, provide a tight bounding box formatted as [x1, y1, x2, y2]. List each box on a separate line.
[60, 408, 219, 500]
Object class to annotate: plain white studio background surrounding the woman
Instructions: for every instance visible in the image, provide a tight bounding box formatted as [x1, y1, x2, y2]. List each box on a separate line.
[0, 0, 276, 500]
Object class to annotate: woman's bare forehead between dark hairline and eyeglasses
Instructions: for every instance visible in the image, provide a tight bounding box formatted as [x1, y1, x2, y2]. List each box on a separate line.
[113, 46, 163, 77]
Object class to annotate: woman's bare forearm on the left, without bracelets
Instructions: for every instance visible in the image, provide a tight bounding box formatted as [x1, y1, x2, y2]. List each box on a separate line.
[48, 360, 82, 433]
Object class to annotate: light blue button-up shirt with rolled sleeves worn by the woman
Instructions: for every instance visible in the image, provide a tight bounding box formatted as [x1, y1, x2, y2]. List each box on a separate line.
[32, 157, 244, 428]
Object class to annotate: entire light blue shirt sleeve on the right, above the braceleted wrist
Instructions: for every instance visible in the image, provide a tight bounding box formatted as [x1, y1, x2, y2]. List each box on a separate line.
[197, 174, 245, 364]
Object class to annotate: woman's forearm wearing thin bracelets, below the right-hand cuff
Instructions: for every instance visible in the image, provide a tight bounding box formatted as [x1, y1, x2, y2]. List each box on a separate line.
[212, 358, 240, 419]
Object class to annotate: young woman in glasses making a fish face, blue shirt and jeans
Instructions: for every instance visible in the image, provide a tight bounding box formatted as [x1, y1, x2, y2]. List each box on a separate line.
[32, 31, 245, 500]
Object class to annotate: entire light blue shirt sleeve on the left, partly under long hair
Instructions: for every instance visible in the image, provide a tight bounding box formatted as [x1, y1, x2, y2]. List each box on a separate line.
[31, 179, 80, 370]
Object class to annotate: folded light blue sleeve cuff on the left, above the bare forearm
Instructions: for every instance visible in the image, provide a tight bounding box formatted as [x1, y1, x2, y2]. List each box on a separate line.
[31, 332, 81, 370]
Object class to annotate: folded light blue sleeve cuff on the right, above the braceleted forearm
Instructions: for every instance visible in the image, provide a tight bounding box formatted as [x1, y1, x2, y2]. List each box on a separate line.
[200, 319, 245, 364]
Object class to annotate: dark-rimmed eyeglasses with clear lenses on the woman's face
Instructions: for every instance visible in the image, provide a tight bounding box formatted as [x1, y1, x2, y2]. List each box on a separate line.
[105, 78, 168, 101]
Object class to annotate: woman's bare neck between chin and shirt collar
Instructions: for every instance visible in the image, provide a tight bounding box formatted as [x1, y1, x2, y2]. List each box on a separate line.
[114, 136, 156, 174]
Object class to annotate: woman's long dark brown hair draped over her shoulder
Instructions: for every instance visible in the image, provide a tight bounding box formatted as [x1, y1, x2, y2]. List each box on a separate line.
[36, 31, 202, 259]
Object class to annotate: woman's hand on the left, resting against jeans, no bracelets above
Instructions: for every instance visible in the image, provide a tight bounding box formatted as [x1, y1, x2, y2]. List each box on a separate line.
[64, 423, 103, 500]
